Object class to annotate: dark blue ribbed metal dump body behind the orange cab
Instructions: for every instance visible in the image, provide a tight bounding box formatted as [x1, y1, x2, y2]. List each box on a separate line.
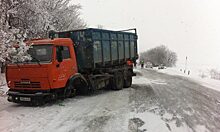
[49, 28, 138, 72]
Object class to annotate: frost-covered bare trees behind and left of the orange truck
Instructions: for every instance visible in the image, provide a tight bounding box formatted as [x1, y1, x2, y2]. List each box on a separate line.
[0, 0, 86, 72]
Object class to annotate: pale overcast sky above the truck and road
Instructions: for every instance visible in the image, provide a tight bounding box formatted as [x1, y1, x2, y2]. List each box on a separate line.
[73, 0, 220, 66]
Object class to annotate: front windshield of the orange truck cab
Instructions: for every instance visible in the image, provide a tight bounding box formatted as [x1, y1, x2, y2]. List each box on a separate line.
[28, 44, 52, 63]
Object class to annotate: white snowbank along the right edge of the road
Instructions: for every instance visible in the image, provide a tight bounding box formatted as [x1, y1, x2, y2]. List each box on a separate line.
[154, 68, 220, 91]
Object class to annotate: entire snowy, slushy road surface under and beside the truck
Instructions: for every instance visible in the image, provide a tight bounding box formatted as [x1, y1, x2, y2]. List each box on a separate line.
[0, 69, 220, 132]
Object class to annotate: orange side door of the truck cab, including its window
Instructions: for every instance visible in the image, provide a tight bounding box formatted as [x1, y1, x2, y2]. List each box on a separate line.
[53, 46, 75, 88]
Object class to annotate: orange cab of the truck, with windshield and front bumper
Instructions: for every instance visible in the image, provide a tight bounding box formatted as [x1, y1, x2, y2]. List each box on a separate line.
[6, 38, 78, 102]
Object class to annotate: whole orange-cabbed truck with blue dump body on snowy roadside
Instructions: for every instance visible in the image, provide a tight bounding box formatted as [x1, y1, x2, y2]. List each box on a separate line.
[6, 28, 138, 104]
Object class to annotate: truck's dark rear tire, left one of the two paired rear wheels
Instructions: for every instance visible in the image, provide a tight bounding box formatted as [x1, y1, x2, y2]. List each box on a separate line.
[112, 72, 124, 90]
